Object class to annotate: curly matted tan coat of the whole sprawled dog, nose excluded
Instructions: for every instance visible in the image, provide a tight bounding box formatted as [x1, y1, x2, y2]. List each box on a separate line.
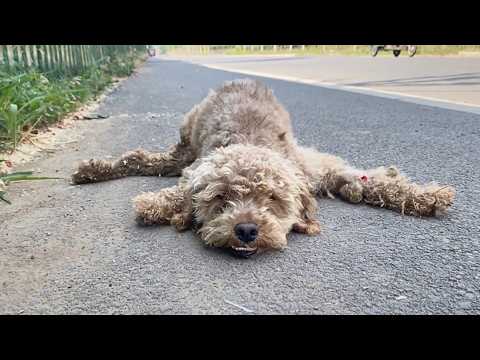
[72, 79, 455, 254]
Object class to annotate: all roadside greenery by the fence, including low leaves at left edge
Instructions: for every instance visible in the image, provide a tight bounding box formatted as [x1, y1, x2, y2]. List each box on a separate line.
[0, 45, 146, 204]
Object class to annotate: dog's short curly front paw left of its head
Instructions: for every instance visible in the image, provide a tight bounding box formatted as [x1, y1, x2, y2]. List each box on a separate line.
[133, 185, 192, 231]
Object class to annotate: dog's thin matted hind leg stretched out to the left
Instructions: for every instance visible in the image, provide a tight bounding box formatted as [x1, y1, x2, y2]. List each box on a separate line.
[72, 143, 195, 184]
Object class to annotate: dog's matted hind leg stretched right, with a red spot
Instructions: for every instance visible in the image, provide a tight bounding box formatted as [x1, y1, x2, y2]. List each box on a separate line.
[302, 149, 455, 216]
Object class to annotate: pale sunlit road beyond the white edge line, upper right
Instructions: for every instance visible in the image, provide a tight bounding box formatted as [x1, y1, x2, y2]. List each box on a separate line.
[175, 52, 480, 109]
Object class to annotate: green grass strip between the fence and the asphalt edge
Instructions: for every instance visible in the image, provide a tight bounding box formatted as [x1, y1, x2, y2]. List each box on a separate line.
[0, 51, 143, 151]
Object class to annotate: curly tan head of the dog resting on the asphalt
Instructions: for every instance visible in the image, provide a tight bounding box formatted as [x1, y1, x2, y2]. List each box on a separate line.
[178, 145, 316, 256]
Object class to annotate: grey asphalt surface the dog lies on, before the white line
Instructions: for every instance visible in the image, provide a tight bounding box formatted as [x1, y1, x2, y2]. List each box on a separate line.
[0, 59, 480, 314]
